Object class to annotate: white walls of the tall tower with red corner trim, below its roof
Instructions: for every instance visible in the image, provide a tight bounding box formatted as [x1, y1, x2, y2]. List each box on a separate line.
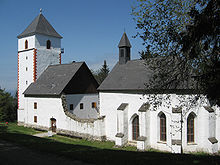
[18, 34, 61, 122]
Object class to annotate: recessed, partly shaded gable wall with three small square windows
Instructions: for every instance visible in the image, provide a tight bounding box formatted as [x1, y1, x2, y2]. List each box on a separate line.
[66, 94, 99, 119]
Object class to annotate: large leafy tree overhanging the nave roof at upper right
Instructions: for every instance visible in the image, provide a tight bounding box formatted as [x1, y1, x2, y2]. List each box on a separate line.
[132, 0, 220, 105]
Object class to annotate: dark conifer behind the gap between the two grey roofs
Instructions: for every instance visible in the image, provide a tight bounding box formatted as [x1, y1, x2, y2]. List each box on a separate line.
[92, 60, 109, 84]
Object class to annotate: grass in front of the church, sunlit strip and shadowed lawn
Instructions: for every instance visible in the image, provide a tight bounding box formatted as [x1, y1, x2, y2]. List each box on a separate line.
[0, 123, 220, 164]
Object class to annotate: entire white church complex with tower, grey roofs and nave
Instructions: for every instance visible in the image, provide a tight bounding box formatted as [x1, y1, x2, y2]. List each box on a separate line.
[18, 13, 220, 153]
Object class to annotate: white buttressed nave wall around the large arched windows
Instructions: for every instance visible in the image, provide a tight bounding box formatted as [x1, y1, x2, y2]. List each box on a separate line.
[99, 92, 220, 153]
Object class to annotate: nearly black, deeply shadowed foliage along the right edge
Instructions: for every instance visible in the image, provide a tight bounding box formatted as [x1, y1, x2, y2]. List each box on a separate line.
[180, 0, 220, 105]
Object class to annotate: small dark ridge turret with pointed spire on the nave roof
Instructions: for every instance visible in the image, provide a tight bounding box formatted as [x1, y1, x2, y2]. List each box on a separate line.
[118, 32, 131, 64]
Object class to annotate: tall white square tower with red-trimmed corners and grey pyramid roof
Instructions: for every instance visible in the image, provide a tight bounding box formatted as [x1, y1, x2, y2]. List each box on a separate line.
[17, 10, 62, 122]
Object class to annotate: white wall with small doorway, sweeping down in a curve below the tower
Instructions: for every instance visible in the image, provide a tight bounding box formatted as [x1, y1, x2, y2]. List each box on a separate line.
[24, 97, 104, 139]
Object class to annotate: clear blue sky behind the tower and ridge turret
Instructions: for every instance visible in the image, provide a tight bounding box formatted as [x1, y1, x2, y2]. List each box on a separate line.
[0, 0, 143, 91]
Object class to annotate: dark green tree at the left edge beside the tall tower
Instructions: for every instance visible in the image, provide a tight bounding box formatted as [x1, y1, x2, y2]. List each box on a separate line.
[0, 88, 17, 121]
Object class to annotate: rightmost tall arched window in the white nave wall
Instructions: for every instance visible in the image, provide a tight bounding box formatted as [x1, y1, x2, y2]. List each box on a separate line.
[187, 113, 195, 143]
